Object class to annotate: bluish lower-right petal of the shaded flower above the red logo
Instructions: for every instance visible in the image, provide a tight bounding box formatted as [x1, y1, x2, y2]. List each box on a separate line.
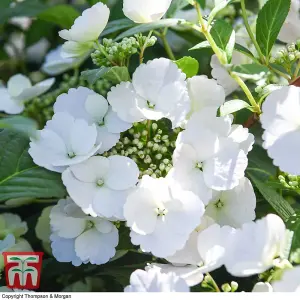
[75, 227, 119, 265]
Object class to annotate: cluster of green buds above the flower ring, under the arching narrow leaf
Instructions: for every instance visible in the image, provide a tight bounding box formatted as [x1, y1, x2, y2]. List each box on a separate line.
[91, 34, 157, 67]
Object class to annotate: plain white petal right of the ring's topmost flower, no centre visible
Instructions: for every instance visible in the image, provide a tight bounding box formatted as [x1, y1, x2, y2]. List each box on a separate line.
[188, 75, 225, 112]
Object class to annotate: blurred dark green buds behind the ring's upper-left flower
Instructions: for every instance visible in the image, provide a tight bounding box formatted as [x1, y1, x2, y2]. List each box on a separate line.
[23, 74, 111, 127]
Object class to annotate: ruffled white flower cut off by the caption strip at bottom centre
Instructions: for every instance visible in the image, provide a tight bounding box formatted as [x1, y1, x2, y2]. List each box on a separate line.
[124, 268, 189, 293]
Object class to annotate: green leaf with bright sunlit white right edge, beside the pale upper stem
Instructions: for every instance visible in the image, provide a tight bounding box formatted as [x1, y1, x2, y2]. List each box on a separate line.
[210, 20, 235, 63]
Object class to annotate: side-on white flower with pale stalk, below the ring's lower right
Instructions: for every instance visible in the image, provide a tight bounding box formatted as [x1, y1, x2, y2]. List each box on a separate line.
[166, 217, 235, 286]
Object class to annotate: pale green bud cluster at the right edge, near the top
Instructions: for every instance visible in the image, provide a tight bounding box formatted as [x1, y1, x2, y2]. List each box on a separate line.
[270, 40, 300, 74]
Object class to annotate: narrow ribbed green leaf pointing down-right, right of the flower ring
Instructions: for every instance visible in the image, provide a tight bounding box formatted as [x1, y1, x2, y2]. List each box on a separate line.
[247, 169, 295, 221]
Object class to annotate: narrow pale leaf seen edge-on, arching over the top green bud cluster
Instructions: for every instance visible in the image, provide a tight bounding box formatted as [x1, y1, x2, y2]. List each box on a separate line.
[115, 19, 182, 41]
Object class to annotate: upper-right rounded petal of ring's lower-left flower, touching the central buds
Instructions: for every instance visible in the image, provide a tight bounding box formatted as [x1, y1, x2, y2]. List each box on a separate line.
[105, 155, 139, 191]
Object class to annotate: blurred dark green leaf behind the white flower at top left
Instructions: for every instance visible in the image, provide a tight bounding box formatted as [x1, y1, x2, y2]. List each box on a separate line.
[38, 4, 80, 29]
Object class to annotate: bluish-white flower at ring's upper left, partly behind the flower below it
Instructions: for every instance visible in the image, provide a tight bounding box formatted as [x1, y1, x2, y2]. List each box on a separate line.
[53, 87, 132, 153]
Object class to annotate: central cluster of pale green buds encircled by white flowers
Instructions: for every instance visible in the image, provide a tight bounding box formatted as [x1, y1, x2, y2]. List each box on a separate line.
[103, 119, 180, 178]
